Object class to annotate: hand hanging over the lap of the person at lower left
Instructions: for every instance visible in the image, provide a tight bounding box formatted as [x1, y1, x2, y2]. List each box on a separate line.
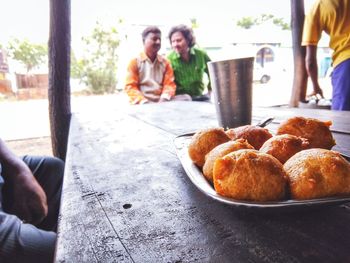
[9, 169, 48, 225]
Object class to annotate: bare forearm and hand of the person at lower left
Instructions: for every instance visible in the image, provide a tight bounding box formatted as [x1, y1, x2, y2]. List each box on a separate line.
[0, 139, 48, 224]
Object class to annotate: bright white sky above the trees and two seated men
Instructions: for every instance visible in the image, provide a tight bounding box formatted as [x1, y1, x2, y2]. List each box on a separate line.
[0, 0, 315, 83]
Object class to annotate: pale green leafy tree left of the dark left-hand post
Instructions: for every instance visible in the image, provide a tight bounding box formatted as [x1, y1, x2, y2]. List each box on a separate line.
[7, 38, 48, 73]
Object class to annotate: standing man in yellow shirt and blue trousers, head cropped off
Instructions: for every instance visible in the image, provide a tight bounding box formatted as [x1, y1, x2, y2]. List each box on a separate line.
[302, 0, 350, 110]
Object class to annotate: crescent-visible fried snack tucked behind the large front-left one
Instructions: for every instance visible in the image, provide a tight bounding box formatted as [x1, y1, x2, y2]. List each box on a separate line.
[203, 139, 254, 182]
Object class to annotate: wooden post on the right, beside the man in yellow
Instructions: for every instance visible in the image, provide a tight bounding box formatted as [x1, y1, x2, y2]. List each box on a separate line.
[289, 0, 308, 107]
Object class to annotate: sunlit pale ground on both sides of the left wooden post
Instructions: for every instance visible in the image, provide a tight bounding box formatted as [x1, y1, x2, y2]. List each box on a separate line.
[0, 94, 128, 156]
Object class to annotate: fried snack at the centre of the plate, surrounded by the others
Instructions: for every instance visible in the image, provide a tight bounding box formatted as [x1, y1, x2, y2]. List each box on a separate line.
[260, 134, 309, 164]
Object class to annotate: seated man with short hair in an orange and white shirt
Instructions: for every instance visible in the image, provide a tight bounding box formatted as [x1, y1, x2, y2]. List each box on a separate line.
[125, 26, 191, 104]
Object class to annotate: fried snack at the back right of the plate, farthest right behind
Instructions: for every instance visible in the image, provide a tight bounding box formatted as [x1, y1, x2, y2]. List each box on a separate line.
[277, 117, 335, 150]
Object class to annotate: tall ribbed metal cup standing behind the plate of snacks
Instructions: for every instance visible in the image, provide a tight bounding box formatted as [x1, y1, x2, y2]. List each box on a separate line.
[208, 57, 254, 129]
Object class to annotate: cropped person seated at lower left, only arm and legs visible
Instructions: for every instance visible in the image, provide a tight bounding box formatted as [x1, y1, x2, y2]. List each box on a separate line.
[0, 139, 64, 263]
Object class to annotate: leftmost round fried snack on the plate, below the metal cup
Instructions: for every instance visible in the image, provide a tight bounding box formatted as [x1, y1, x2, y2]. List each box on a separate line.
[188, 128, 230, 167]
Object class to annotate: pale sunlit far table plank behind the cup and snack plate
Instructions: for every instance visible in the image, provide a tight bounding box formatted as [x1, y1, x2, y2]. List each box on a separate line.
[128, 102, 350, 135]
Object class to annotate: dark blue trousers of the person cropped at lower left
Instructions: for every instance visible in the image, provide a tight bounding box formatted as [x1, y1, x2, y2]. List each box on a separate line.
[0, 156, 64, 263]
